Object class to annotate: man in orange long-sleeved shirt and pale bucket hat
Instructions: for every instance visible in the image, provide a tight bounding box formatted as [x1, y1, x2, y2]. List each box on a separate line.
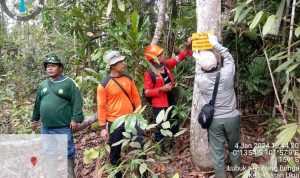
[97, 51, 143, 178]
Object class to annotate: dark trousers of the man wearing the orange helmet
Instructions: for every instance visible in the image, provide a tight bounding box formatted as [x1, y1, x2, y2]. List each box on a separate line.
[151, 108, 179, 142]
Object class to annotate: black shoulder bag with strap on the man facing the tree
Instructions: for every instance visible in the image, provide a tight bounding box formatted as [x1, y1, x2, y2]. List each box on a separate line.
[198, 72, 220, 129]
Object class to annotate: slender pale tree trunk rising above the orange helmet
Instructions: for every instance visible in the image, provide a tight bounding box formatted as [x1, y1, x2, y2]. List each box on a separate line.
[151, 0, 167, 44]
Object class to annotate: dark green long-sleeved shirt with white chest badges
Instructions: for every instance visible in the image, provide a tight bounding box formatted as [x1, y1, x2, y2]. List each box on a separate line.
[31, 77, 84, 128]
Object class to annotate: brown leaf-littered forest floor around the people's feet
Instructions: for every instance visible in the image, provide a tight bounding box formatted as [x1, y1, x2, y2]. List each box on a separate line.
[75, 117, 269, 178]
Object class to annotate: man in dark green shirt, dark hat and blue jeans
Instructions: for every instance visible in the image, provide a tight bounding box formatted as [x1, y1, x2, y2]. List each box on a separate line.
[31, 56, 84, 178]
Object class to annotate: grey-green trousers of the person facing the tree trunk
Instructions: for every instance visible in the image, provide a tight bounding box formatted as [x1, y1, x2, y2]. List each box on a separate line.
[208, 116, 241, 178]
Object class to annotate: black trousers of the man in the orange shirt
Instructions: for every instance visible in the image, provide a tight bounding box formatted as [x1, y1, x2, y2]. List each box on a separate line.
[108, 123, 146, 178]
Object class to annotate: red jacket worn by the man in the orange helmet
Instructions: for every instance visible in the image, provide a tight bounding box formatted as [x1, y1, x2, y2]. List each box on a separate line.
[144, 49, 192, 108]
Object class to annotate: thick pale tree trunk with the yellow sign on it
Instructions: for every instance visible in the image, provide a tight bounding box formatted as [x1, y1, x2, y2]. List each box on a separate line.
[190, 0, 221, 171]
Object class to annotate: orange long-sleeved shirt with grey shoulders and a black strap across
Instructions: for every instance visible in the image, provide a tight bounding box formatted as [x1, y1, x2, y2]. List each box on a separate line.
[97, 75, 141, 126]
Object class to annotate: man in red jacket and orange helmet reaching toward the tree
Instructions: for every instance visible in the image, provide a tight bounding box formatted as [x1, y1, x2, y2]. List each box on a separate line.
[144, 38, 193, 152]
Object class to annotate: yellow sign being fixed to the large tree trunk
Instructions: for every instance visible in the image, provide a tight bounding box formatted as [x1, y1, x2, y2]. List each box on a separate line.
[192, 32, 213, 51]
